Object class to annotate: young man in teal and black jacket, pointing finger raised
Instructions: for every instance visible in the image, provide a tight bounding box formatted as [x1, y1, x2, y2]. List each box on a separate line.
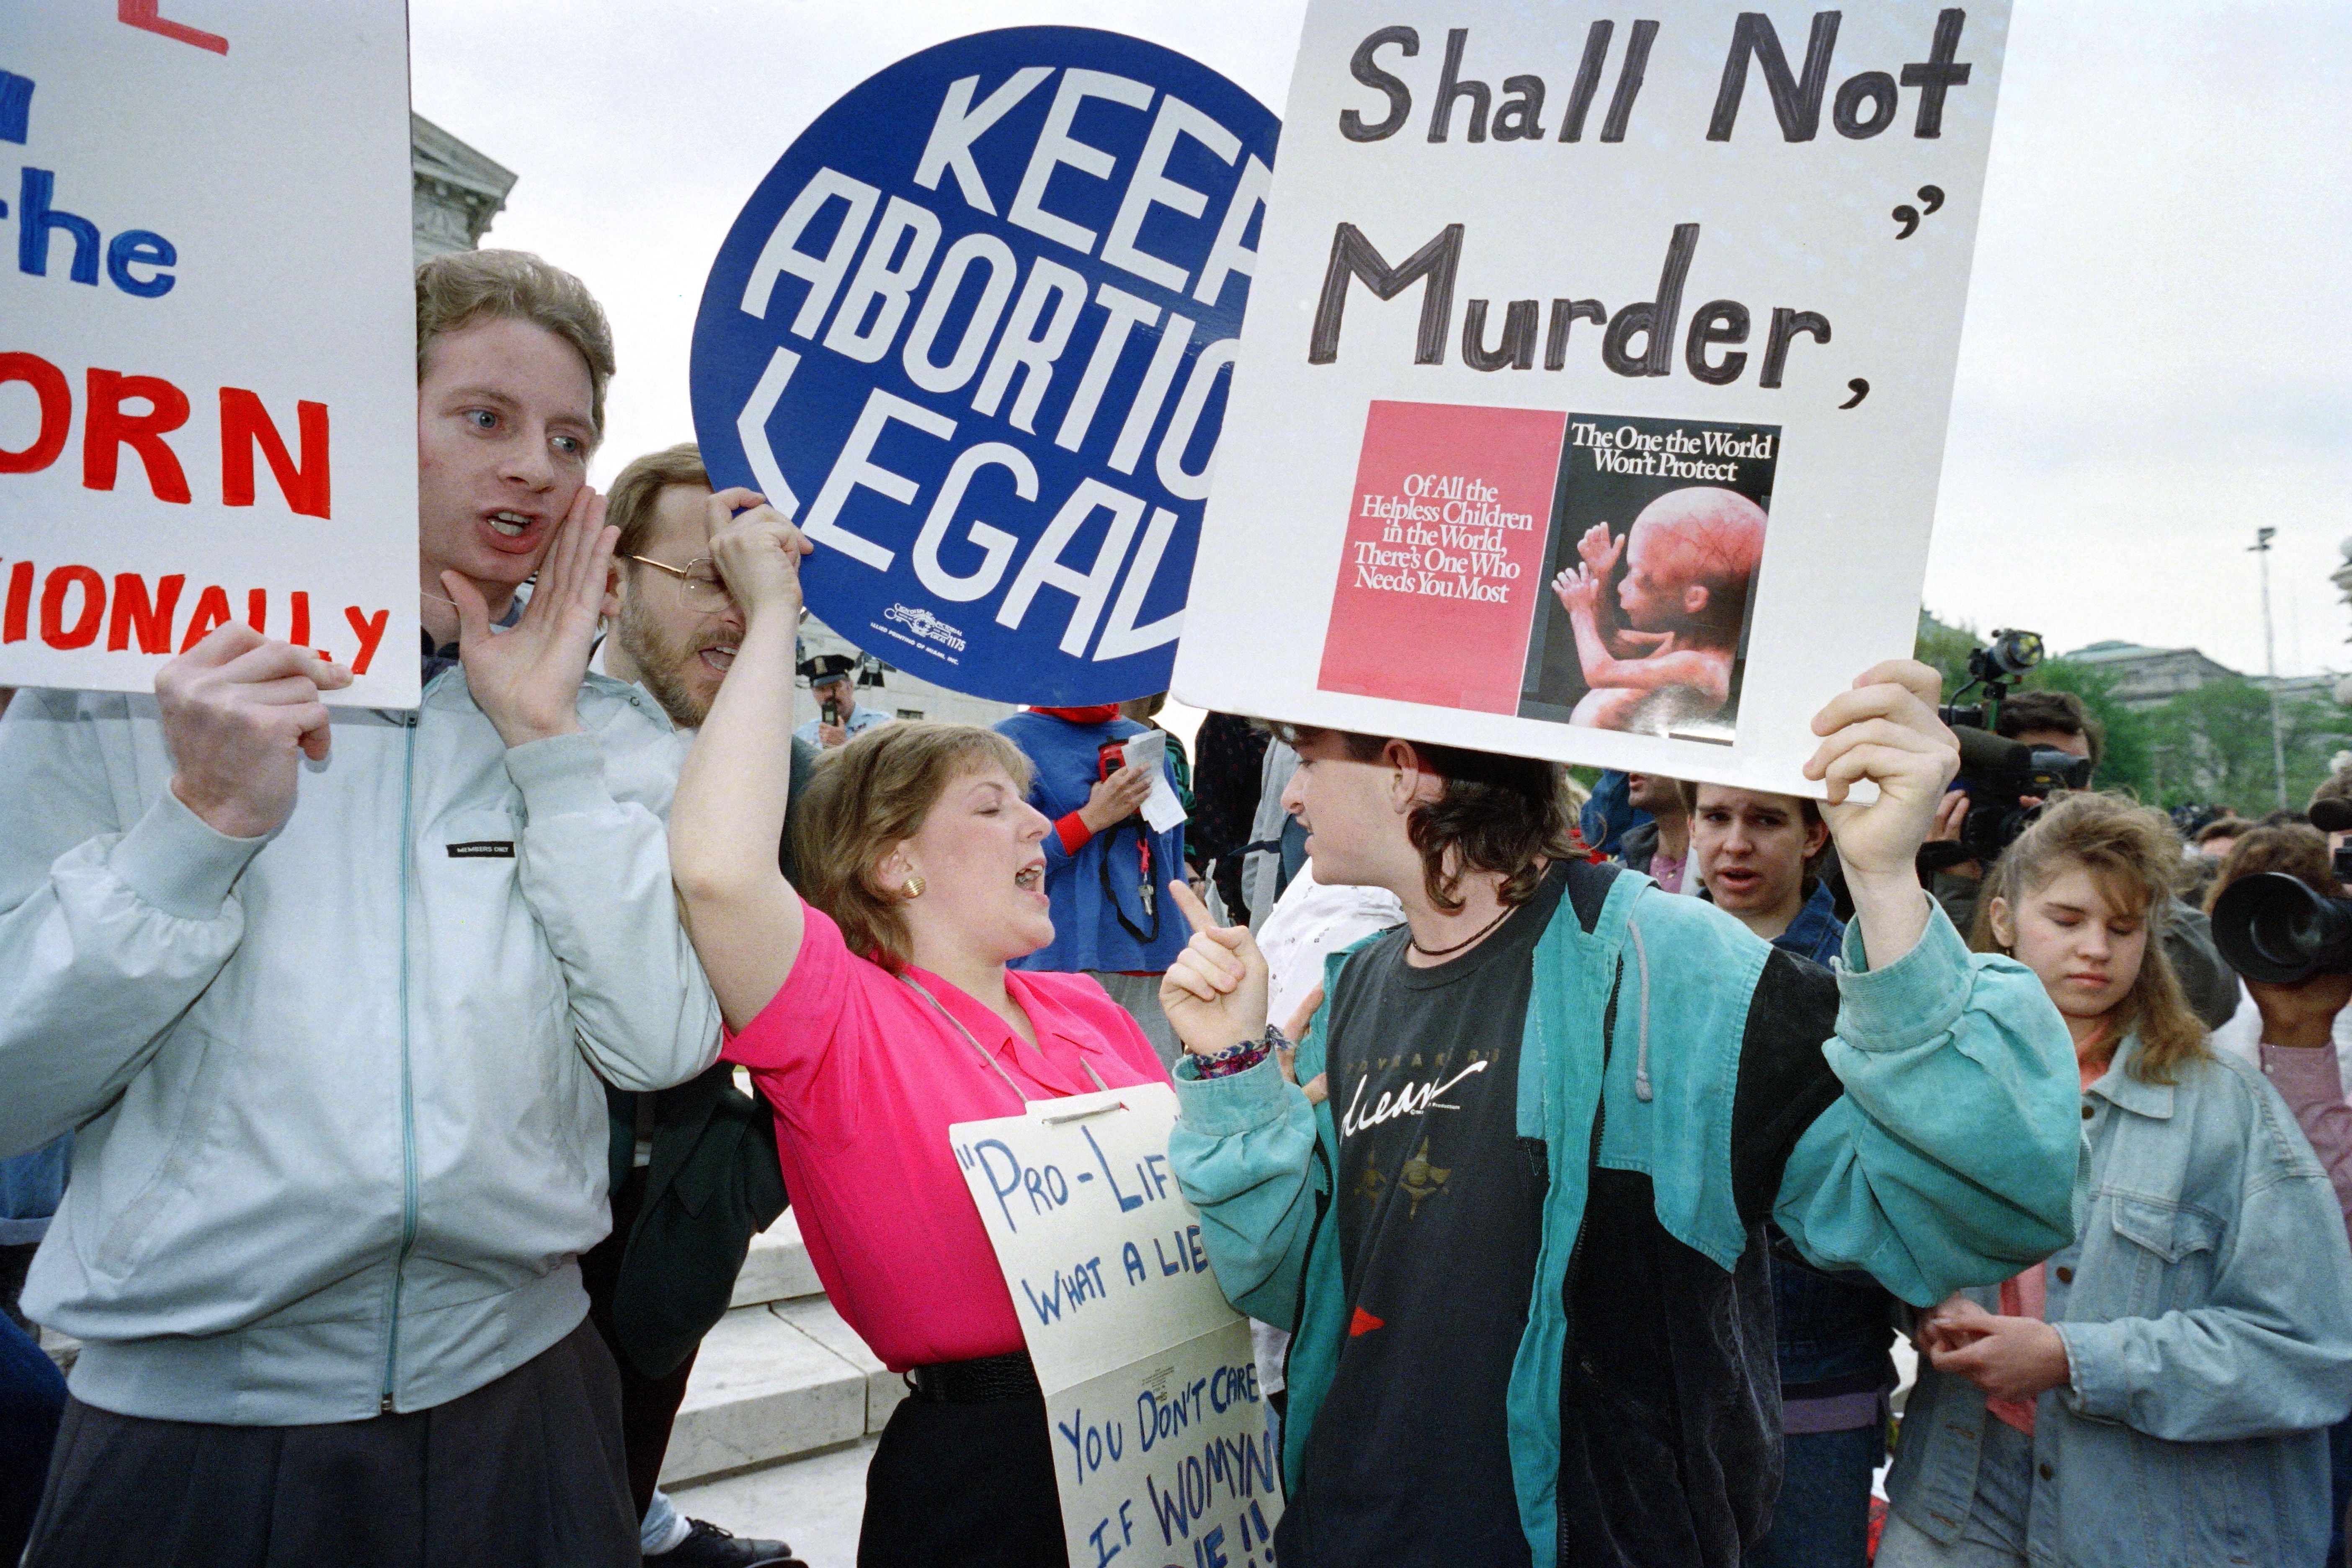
[1162, 660, 2081, 1568]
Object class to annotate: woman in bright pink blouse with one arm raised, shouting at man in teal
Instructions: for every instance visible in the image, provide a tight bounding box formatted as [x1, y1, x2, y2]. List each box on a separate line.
[671, 515, 1167, 1568]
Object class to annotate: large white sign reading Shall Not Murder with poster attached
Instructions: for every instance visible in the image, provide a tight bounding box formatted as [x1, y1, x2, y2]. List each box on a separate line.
[1173, 0, 2009, 794]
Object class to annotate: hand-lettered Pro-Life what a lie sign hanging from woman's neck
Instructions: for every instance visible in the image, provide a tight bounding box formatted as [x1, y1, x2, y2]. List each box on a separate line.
[948, 1084, 1282, 1568]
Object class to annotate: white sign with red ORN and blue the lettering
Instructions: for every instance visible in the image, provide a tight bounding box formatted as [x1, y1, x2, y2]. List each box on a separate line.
[0, 0, 416, 708]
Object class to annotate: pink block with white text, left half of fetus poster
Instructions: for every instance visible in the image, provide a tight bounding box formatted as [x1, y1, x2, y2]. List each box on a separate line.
[1317, 402, 1569, 712]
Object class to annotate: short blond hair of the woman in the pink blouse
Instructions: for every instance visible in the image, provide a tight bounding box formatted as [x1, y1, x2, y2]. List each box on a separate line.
[793, 720, 1030, 973]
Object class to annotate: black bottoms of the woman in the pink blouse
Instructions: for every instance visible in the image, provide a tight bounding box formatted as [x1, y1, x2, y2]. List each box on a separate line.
[859, 1396, 1070, 1568]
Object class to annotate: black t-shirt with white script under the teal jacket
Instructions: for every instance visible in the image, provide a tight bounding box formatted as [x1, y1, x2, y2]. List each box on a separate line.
[1279, 865, 1566, 1568]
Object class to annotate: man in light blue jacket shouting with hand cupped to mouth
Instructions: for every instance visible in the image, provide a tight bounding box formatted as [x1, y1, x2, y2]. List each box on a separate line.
[0, 252, 717, 1568]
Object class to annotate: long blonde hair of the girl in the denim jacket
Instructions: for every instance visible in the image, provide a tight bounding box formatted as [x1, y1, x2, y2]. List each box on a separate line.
[1969, 792, 2211, 1084]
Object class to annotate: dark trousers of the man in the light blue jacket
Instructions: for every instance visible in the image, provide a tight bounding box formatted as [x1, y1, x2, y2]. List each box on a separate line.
[26, 1323, 642, 1568]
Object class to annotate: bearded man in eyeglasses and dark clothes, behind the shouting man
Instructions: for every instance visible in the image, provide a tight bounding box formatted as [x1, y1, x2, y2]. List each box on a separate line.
[581, 442, 816, 1568]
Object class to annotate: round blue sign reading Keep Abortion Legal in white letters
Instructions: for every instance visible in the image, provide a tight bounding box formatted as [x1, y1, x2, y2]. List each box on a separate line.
[694, 28, 1277, 705]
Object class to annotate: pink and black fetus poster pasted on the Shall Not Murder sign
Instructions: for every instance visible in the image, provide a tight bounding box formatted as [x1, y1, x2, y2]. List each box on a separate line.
[1320, 402, 1780, 743]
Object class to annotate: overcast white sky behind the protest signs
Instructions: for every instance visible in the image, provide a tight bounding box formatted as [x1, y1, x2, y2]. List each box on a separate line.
[409, 0, 2352, 672]
